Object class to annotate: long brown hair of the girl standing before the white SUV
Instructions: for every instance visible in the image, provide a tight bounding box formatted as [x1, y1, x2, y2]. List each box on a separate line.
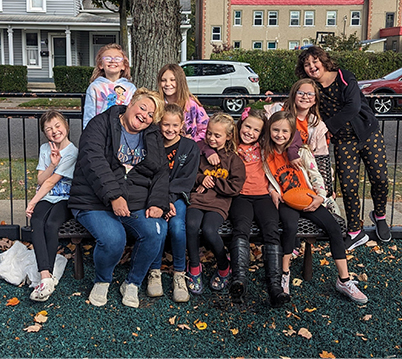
[157, 64, 201, 111]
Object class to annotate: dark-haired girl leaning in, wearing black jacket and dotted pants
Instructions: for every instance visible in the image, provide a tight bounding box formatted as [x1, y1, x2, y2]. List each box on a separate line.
[296, 46, 391, 250]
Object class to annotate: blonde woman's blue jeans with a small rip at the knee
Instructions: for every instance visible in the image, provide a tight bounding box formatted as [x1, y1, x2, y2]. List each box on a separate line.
[77, 210, 167, 286]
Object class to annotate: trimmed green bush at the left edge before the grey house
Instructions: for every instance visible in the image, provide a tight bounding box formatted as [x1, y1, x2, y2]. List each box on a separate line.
[0, 65, 28, 92]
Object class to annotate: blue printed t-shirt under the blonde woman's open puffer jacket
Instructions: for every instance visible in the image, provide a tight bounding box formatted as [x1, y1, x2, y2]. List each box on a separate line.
[117, 126, 147, 173]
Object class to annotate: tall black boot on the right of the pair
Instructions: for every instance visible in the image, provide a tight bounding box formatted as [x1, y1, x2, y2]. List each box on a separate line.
[263, 244, 290, 308]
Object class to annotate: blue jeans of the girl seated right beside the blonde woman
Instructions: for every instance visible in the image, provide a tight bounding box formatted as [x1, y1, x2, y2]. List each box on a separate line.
[151, 199, 187, 272]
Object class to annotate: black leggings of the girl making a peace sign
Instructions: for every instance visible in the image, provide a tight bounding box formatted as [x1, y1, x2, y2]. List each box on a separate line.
[31, 200, 71, 273]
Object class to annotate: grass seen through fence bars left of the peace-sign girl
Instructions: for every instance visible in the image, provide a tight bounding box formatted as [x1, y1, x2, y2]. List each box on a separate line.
[0, 159, 38, 200]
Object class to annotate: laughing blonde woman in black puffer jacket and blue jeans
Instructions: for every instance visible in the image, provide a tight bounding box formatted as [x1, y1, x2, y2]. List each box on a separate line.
[69, 88, 169, 308]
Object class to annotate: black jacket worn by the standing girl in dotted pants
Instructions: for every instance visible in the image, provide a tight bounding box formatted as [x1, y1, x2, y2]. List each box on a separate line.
[321, 69, 378, 142]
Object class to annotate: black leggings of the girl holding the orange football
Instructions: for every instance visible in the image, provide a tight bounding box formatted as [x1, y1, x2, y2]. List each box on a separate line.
[279, 203, 346, 259]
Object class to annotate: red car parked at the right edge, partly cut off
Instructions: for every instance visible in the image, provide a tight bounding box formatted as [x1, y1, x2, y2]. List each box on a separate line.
[358, 68, 402, 113]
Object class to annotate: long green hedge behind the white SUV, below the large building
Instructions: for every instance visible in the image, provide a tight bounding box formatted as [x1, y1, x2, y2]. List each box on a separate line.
[211, 49, 402, 93]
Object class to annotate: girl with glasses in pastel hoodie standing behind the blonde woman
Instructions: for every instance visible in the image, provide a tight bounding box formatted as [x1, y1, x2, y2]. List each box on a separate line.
[83, 44, 136, 128]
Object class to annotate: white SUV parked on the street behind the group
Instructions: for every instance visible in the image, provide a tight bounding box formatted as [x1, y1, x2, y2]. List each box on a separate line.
[180, 60, 260, 113]
